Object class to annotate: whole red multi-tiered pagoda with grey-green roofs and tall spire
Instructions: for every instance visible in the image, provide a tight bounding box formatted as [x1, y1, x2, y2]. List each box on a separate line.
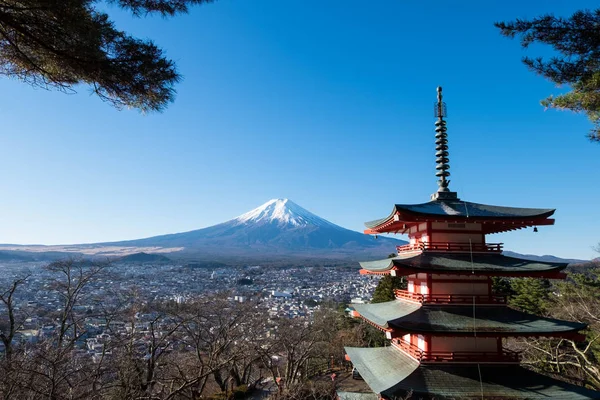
[339, 88, 600, 399]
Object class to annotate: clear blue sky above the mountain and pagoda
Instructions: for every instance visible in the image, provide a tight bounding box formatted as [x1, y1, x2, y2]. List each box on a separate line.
[0, 0, 600, 258]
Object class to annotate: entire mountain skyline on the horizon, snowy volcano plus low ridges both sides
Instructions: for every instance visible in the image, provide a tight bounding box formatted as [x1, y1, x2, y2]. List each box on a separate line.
[0, 199, 589, 265]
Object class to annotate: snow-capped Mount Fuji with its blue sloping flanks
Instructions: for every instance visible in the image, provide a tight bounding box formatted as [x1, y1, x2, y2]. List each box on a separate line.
[98, 199, 406, 259]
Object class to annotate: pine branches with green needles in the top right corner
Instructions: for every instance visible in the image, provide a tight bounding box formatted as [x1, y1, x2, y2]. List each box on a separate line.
[495, 9, 600, 141]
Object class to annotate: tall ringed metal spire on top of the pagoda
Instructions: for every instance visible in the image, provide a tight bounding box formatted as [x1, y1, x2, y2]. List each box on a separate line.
[431, 86, 457, 200]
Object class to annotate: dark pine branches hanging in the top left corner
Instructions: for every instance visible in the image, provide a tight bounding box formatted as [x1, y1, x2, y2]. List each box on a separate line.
[0, 0, 212, 112]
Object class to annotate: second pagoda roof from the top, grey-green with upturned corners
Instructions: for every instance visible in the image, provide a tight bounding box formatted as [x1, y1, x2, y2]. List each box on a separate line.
[360, 252, 568, 277]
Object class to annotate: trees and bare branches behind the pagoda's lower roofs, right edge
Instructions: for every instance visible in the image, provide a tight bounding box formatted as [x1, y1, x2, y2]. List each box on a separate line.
[502, 262, 600, 390]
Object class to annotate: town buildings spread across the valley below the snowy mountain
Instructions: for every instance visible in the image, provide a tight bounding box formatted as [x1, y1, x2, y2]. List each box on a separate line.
[0, 262, 379, 357]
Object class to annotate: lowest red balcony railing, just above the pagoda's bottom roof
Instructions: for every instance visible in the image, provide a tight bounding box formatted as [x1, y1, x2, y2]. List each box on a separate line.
[392, 339, 521, 364]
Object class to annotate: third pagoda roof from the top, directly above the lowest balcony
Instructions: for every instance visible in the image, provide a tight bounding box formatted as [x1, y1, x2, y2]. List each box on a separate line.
[355, 300, 586, 336]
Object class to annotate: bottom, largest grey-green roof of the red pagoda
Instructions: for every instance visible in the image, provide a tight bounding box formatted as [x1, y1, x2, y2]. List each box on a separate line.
[345, 346, 600, 400]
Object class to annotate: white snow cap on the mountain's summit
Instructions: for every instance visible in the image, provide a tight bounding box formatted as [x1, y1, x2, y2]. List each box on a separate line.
[234, 199, 332, 226]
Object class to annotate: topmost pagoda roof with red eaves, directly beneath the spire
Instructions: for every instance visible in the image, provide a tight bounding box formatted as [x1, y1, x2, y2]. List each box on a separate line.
[365, 199, 556, 233]
